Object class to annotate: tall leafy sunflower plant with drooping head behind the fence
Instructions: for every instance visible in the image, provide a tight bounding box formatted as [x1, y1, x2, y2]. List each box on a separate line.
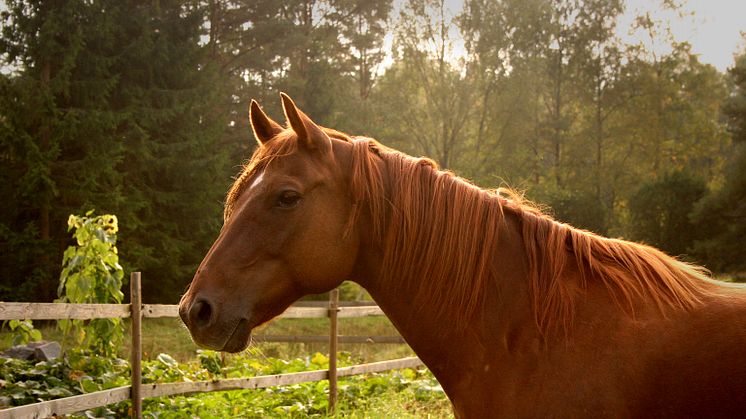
[57, 211, 124, 357]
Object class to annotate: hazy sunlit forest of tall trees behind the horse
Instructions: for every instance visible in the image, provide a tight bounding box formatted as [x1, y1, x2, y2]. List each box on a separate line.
[0, 0, 746, 303]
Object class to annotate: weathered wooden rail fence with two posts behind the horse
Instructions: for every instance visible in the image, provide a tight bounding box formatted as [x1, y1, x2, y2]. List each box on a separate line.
[0, 272, 423, 419]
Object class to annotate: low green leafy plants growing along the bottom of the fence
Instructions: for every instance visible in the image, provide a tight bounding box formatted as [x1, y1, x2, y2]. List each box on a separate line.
[0, 351, 450, 418]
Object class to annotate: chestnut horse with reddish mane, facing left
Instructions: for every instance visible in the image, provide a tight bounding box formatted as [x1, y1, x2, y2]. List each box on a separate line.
[179, 95, 746, 418]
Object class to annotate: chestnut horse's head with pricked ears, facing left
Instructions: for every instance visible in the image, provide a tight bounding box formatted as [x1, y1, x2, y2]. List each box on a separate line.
[179, 95, 358, 352]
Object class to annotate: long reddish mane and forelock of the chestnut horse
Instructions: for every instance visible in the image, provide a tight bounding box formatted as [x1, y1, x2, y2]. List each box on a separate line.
[226, 133, 709, 333]
